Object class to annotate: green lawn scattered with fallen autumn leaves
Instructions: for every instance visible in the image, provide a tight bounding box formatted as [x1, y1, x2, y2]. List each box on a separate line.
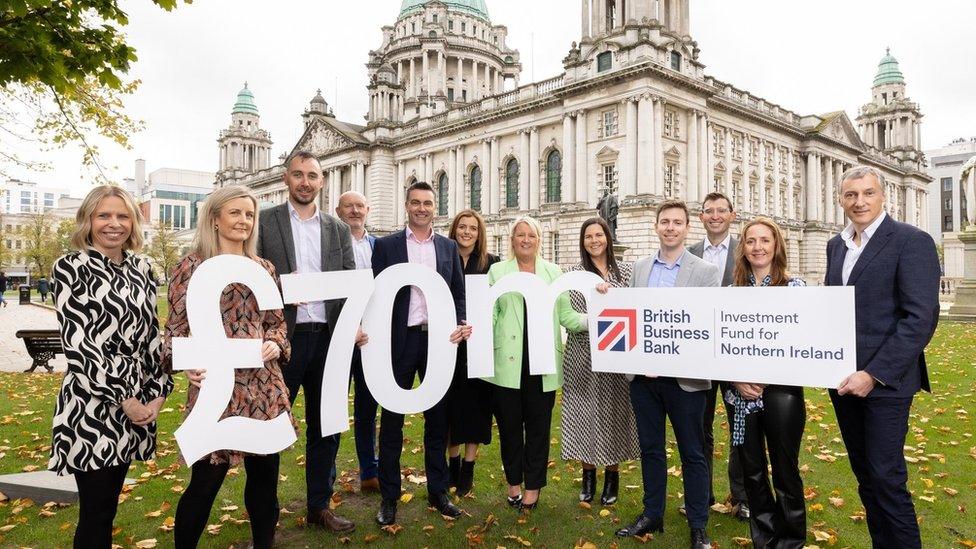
[0, 323, 976, 547]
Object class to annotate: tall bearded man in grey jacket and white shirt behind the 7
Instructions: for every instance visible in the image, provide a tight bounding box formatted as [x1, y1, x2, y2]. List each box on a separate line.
[258, 151, 356, 533]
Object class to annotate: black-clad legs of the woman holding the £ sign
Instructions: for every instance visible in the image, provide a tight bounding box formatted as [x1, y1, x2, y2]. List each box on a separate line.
[173, 454, 279, 549]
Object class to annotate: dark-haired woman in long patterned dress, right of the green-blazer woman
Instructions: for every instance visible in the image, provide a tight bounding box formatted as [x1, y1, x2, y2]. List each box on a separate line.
[562, 217, 640, 505]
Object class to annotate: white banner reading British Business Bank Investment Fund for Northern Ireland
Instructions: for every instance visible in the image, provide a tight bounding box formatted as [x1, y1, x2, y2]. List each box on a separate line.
[589, 287, 856, 388]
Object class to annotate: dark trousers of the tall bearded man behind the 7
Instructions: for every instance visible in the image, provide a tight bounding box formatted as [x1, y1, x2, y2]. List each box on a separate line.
[282, 324, 339, 513]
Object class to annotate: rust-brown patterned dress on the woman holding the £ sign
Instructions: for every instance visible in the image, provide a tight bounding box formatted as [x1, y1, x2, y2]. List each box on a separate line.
[162, 254, 295, 466]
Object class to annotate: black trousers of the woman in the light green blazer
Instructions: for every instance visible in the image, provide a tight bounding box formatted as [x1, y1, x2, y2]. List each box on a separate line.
[492, 358, 556, 490]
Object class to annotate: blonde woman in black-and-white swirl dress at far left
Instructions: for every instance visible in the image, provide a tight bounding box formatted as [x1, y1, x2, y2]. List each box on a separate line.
[48, 185, 173, 548]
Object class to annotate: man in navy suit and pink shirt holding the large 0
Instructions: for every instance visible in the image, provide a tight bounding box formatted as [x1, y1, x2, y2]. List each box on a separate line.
[372, 182, 471, 526]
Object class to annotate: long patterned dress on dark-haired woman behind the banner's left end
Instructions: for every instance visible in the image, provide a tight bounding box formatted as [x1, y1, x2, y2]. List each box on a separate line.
[561, 263, 640, 465]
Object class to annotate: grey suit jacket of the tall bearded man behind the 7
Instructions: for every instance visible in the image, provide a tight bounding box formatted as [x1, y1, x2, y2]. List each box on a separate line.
[258, 202, 356, 339]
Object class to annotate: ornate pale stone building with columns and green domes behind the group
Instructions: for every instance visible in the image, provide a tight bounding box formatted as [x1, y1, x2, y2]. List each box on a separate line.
[217, 0, 930, 284]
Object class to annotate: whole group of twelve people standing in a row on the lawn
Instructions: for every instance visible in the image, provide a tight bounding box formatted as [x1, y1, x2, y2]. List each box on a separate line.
[50, 152, 939, 549]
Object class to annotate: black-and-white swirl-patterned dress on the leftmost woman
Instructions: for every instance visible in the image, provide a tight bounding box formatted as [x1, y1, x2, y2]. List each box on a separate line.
[48, 249, 173, 475]
